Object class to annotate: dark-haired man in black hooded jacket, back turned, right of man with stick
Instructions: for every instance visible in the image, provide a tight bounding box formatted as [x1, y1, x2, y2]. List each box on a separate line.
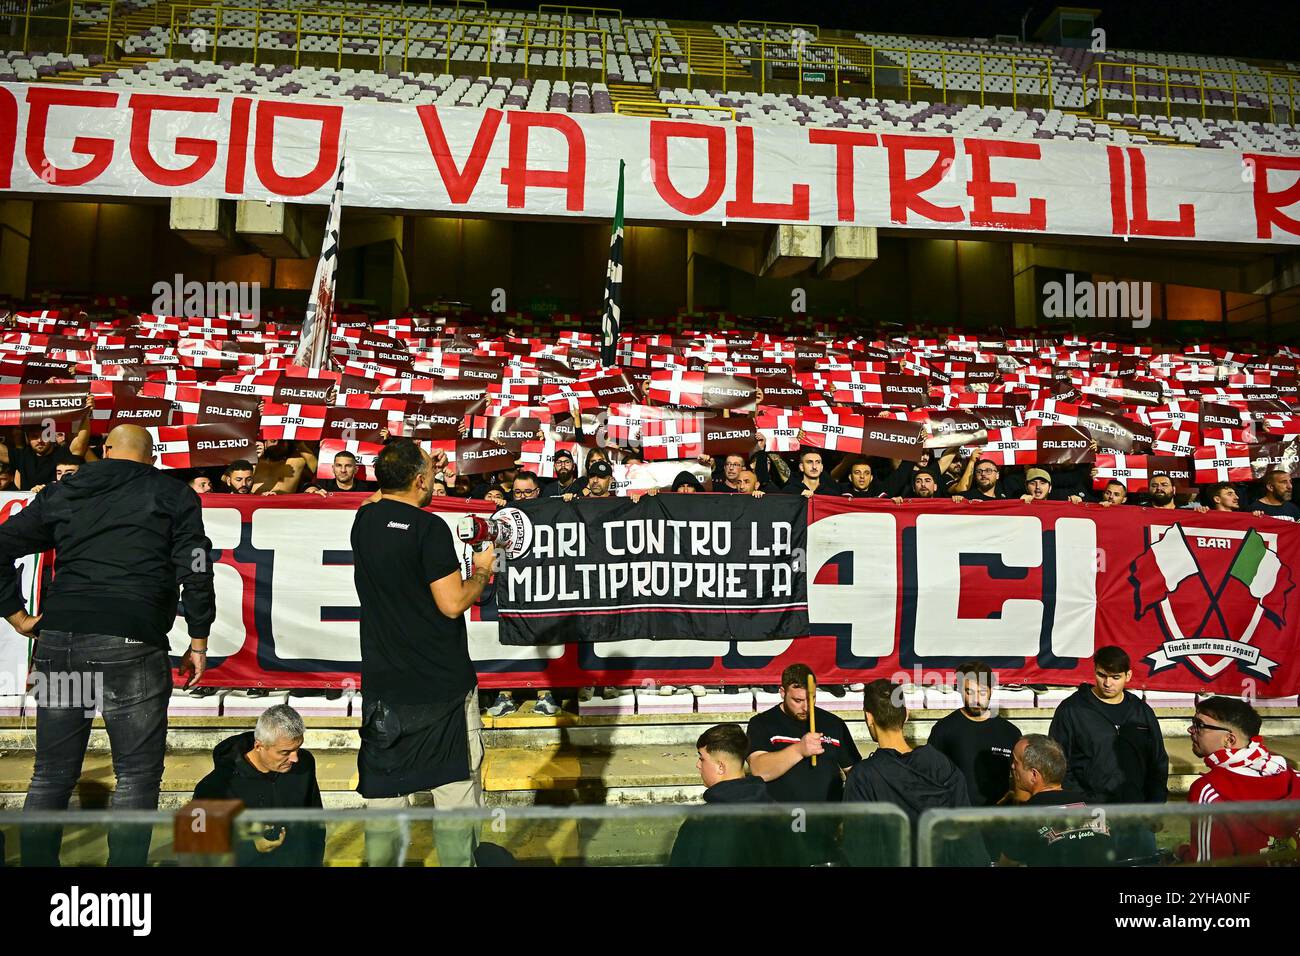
[844, 678, 989, 866]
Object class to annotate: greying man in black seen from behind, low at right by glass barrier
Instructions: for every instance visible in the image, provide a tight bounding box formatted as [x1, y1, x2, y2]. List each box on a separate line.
[998, 734, 1113, 866]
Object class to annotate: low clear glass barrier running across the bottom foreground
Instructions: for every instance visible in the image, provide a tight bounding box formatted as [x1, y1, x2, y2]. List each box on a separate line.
[0, 801, 1300, 868]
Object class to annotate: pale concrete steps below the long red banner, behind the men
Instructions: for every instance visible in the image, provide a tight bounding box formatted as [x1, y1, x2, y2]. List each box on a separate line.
[0, 702, 1300, 809]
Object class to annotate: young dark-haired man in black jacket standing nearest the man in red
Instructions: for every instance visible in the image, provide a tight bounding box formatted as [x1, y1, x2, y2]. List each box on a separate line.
[1048, 646, 1169, 858]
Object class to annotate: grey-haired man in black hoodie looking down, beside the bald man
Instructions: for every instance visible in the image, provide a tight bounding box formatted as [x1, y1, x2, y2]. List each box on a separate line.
[194, 704, 325, 866]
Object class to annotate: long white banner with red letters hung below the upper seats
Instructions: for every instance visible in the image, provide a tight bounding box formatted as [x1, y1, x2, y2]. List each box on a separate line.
[0, 83, 1300, 243]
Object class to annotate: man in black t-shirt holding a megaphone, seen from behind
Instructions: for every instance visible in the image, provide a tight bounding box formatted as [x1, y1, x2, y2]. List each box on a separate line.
[352, 438, 495, 866]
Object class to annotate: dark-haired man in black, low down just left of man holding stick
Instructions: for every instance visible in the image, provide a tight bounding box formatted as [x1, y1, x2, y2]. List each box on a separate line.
[668, 723, 774, 866]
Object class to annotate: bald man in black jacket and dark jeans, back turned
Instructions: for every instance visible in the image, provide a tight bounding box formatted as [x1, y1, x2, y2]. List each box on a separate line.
[0, 425, 216, 866]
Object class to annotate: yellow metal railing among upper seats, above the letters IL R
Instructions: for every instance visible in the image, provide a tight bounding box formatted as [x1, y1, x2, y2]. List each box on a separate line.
[1093, 60, 1296, 122]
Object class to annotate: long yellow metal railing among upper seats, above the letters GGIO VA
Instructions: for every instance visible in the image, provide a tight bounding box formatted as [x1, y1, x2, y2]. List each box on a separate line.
[168, 4, 610, 82]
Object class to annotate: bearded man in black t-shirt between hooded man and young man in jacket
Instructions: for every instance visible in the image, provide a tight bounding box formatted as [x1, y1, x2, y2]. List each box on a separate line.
[928, 661, 1021, 806]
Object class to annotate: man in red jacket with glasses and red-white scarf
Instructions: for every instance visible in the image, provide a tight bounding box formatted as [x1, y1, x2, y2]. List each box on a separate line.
[1180, 697, 1300, 862]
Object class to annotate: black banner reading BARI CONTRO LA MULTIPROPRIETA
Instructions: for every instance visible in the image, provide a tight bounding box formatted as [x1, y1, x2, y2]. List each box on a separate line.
[495, 494, 809, 645]
